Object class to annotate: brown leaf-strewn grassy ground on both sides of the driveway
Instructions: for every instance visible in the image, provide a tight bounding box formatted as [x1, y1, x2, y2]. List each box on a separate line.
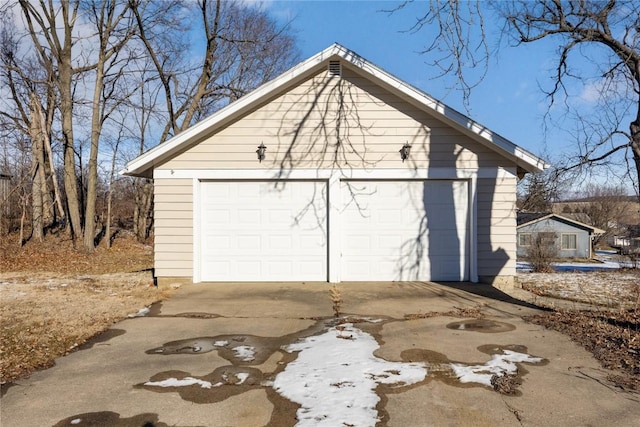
[0, 234, 640, 390]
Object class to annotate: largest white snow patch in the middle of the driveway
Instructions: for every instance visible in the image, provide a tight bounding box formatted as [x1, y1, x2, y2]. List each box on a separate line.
[273, 323, 427, 427]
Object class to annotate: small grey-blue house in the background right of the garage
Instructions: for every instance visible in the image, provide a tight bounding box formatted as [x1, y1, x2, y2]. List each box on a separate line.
[517, 212, 605, 259]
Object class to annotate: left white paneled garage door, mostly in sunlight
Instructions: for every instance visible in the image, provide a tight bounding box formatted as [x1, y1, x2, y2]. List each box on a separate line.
[200, 181, 327, 281]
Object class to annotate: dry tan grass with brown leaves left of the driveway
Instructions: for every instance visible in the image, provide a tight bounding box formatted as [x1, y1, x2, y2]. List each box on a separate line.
[0, 237, 167, 383]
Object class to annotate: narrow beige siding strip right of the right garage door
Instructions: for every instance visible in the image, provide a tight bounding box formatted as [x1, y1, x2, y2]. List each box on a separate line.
[477, 178, 516, 278]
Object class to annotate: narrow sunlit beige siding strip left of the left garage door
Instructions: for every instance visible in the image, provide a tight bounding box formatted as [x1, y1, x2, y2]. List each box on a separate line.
[154, 179, 193, 277]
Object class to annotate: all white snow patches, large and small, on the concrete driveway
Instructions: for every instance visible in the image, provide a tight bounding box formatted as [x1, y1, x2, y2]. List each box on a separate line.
[144, 319, 542, 427]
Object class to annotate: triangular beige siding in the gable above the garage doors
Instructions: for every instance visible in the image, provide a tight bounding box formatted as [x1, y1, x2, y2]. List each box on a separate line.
[159, 69, 505, 169]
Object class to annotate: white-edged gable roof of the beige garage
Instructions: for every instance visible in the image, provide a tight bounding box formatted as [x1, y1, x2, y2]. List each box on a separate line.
[121, 43, 548, 178]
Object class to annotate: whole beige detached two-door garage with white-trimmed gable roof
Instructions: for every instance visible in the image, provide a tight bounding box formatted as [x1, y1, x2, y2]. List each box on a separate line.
[123, 44, 547, 284]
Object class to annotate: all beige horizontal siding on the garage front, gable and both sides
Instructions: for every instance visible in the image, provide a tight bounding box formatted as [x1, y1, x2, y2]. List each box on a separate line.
[155, 66, 516, 278]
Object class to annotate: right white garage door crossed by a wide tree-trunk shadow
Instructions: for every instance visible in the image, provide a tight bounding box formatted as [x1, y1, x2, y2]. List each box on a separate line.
[341, 180, 469, 281]
